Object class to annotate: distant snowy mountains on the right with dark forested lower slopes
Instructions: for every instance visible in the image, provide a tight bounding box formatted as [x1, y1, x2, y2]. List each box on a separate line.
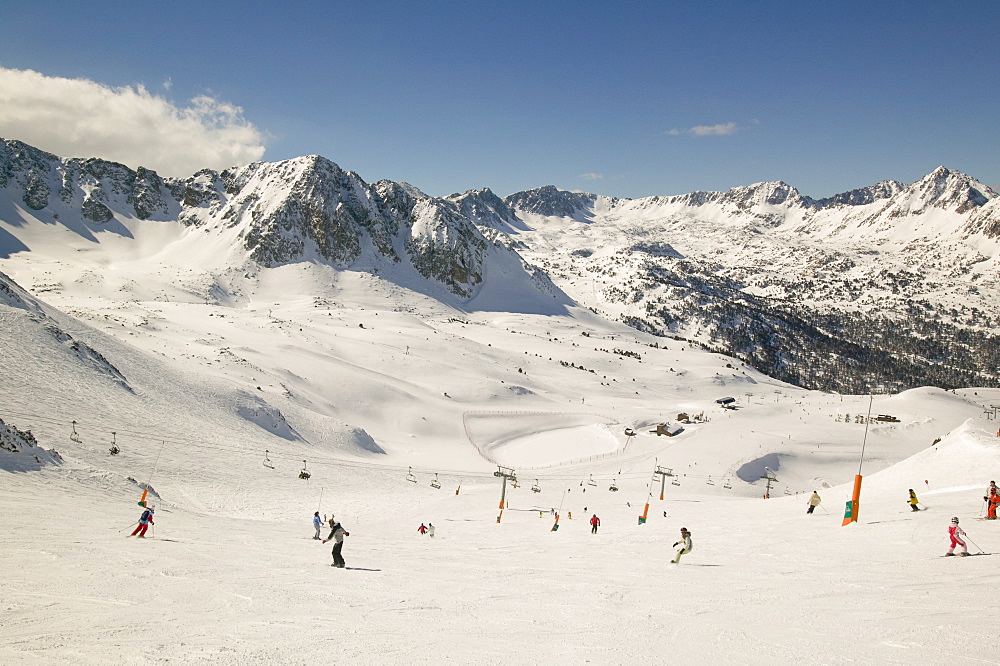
[452, 167, 1000, 392]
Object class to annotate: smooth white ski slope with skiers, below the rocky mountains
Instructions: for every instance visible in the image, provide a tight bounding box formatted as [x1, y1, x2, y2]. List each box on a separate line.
[0, 139, 1000, 664]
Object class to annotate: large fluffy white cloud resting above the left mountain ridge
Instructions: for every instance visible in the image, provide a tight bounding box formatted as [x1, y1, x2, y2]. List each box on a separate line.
[0, 67, 264, 176]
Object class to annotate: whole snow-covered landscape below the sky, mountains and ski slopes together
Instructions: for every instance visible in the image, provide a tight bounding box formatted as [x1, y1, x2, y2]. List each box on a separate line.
[0, 140, 1000, 664]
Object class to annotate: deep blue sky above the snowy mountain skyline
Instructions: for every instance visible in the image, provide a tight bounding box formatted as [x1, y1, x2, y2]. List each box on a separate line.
[0, 0, 1000, 198]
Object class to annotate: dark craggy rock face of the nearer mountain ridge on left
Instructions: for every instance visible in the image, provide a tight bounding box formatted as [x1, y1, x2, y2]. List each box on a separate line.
[0, 140, 510, 298]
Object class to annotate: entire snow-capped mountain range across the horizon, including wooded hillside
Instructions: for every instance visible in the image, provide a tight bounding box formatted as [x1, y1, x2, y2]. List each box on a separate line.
[0, 135, 1000, 392]
